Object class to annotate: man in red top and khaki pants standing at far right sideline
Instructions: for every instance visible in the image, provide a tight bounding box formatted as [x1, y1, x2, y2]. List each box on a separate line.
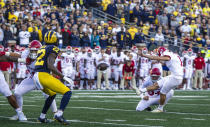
[193, 53, 205, 90]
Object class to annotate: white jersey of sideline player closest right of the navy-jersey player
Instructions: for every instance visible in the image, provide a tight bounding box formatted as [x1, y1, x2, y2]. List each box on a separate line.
[61, 53, 74, 69]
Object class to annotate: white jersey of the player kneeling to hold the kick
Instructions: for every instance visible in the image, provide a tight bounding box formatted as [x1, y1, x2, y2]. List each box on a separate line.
[141, 76, 161, 98]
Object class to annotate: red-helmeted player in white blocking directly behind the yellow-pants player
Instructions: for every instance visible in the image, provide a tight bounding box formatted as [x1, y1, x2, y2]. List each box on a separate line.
[10, 40, 57, 123]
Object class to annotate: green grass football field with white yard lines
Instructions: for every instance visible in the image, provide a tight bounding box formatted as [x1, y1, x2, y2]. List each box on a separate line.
[0, 91, 210, 127]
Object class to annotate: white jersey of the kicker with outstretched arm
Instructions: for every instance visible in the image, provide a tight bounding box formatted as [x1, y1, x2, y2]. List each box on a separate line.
[163, 51, 184, 79]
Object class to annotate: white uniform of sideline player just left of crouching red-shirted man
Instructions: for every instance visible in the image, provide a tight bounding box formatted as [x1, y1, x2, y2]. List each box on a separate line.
[112, 53, 124, 82]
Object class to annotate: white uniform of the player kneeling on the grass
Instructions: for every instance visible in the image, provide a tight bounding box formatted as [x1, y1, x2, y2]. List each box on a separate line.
[136, 76, 174, 111]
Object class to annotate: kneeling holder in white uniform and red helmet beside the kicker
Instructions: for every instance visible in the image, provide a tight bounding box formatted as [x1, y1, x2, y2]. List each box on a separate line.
[136, 68, 174, 111]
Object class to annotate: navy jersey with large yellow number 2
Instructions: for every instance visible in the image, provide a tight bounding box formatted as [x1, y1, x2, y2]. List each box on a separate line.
[35, 45, 60, 73]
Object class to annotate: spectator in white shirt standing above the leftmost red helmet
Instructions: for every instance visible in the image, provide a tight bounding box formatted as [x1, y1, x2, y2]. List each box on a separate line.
[19, 25, 31, 47]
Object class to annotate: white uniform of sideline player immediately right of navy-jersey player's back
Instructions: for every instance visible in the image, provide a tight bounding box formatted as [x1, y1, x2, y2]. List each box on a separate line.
[61, 53, 75, 80]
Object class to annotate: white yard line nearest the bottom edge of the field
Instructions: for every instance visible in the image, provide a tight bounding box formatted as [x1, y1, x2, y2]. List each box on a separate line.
[0, 116, 164, 127]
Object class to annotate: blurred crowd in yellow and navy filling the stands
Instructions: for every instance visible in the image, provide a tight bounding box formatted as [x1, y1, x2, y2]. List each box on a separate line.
[0, 0, 210, 90]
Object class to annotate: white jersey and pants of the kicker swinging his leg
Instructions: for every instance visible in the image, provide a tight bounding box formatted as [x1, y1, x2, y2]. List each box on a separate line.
[157, 50, 184, 94]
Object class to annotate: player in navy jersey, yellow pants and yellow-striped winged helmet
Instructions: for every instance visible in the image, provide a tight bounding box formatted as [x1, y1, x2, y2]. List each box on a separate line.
[33, 31, 73, 125]
